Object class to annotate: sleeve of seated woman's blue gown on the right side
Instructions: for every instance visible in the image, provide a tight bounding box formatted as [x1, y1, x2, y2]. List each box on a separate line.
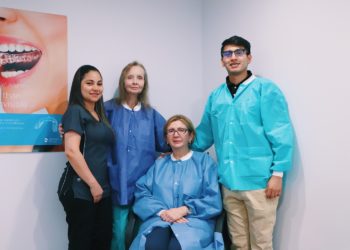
[184, 155, 222, 219]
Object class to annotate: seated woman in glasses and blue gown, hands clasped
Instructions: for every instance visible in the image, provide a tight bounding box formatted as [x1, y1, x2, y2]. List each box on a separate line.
[130, 115, 223, 250]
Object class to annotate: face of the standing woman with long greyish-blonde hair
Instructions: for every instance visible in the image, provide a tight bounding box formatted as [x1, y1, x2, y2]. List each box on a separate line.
[124, 66, 145, 96]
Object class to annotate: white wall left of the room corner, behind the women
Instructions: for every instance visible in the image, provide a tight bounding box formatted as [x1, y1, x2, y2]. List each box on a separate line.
[0, 0, 202, 250]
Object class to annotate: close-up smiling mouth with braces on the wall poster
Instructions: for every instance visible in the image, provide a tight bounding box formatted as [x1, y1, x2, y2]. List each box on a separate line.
[0, 8, 67, 113]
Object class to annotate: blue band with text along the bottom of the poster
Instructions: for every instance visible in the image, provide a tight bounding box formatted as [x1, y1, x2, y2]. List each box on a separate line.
[0, 114, 62, 146]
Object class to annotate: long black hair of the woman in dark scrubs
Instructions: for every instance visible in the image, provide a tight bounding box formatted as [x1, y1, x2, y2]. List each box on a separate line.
[69, 65, 110, 127]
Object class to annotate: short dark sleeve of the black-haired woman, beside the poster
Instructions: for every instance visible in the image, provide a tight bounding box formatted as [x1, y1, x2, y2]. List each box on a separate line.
[62, 105, 84, 135]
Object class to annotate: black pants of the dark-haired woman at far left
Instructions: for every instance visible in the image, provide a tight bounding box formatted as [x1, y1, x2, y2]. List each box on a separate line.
[60, 190, 112, 250]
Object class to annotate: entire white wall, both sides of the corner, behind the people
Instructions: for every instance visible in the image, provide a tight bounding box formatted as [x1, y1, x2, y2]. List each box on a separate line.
[0, 0, 350, 250]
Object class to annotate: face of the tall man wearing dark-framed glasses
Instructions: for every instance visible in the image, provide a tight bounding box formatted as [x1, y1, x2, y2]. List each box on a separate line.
[221, 45, 252, 77]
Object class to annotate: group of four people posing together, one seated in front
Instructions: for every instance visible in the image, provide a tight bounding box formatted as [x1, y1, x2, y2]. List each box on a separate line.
[58, 36, 294, 250]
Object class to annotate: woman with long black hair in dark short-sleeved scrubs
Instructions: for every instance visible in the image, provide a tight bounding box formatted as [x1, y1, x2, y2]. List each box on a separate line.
[58, 65, 114, 250]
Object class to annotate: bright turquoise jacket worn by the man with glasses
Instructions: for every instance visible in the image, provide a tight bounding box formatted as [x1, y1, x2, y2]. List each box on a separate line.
[192, 75, 294, 191]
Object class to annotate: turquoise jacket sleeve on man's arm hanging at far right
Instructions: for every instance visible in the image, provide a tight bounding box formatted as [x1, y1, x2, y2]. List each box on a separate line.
[261, 83, 294, 172]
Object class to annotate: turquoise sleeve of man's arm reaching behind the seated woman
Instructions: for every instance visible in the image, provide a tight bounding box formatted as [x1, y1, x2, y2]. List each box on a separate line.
[191, 96, 214, 152]
